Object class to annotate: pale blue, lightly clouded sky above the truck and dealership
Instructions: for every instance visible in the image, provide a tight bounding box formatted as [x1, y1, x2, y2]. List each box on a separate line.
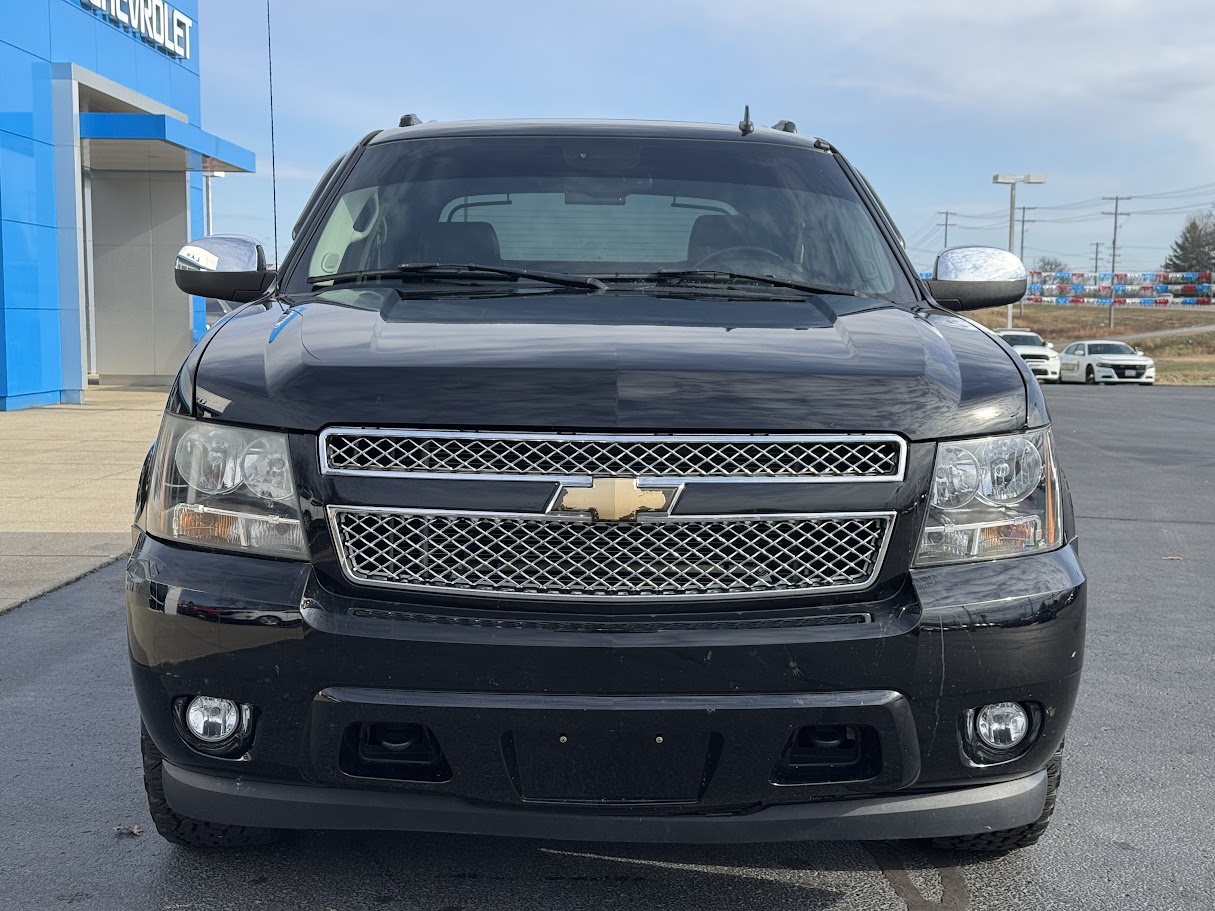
[199, 0, 1215, 271]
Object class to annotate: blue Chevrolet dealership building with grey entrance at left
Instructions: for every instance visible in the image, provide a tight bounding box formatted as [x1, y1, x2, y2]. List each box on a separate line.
[0, 0, 254, 411]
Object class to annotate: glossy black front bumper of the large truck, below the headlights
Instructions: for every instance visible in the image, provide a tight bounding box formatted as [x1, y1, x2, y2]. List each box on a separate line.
[128, 537, 1085, 841]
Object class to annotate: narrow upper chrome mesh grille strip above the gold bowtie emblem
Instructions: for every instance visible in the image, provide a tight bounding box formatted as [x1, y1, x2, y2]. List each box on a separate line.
[321, 428, 906, 482]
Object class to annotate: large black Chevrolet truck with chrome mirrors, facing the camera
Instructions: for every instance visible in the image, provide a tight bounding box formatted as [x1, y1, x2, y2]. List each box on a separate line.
[126, 119, 1085, 850]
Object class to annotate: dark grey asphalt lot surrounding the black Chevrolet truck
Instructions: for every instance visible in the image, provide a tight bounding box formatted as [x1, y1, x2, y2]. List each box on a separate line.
[0, 386, 1215, 911]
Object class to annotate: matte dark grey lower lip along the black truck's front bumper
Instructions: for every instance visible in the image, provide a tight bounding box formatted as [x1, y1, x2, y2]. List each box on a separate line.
[163, 763, 1046, 843]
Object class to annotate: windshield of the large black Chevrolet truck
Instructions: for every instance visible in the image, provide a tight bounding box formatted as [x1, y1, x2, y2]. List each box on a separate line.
[283, 137, 915, 301]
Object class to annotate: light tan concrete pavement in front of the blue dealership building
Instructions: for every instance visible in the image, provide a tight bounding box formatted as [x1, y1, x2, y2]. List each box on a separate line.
[0, 386, 165, 613]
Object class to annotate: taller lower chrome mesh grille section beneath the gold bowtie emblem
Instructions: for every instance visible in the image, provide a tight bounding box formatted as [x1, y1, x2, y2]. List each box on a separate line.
[329, 507, 894, 600]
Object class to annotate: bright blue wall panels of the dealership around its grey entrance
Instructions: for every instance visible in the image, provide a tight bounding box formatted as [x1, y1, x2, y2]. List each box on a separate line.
[0, 0, 205, 411]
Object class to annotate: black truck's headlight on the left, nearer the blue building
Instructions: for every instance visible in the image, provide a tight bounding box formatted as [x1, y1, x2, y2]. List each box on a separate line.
[147, 414, 307, 560]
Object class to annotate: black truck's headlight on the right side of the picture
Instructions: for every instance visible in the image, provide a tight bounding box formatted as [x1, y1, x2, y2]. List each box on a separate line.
[916, 428, 1063, 566]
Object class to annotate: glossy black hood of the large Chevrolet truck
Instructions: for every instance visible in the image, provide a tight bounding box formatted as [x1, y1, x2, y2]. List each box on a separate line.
[194, 292, 1025, 440]
